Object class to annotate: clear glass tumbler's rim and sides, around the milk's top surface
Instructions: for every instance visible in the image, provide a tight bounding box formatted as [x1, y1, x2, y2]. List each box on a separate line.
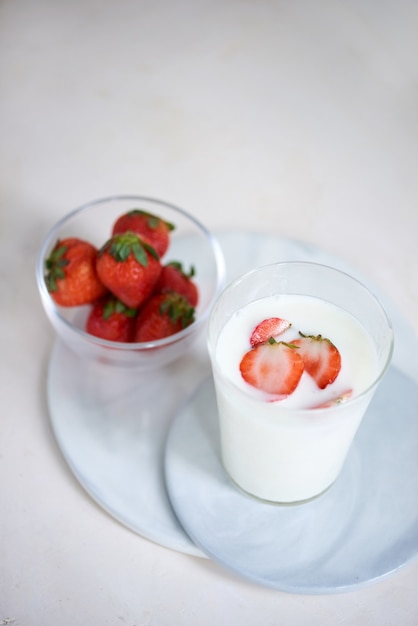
[208, 262, 393, 503]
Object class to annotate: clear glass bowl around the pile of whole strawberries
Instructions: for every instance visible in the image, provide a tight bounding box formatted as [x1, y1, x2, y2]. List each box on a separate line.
[36, 195, 225, 369]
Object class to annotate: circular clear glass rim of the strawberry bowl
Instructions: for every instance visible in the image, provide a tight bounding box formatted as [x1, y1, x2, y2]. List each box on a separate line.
[36, 194, 226, 352]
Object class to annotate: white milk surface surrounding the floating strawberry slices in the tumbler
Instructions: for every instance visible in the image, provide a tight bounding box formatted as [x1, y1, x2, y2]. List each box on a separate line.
[215, 295, 377, 408]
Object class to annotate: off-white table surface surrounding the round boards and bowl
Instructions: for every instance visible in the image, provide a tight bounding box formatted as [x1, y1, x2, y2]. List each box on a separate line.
[0, 0, 418, 626]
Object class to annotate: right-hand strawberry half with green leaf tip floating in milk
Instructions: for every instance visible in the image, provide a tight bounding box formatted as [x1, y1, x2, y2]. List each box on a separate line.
[292, 332, 341, 389]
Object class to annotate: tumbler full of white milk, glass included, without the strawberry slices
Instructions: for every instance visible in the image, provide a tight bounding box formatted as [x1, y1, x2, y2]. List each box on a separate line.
[209, 263, 393, 503]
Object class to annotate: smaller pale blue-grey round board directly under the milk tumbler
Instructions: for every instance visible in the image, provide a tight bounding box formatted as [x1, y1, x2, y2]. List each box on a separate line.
[165, 368, 418, 594]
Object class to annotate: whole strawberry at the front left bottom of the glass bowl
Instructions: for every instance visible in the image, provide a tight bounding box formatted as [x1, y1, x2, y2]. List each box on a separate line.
[86, 296, 137, 342]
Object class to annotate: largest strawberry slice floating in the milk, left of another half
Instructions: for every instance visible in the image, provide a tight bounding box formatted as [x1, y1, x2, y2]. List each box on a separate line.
[240, 339, 303, 397]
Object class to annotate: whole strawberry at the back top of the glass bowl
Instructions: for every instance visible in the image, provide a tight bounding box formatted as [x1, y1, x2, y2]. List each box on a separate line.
[112, 209, 174, 258]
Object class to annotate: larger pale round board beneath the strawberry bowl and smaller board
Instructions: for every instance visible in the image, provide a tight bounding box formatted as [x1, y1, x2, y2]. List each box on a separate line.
[48, 232, 418, 556]
